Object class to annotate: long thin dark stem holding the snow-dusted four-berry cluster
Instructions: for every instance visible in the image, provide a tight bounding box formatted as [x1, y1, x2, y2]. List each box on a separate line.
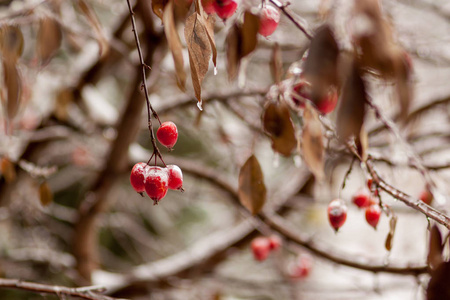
[127, 0, 166, 166]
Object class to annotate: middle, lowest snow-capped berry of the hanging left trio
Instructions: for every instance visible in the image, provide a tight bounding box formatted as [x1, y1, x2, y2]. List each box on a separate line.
[144, 167, 169, 204]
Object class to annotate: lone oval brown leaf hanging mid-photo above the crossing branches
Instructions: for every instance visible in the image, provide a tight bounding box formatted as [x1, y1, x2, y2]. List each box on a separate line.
[238, 155, 267, 215]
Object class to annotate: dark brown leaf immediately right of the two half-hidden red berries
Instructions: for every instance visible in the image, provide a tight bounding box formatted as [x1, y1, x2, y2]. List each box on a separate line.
[336, 62, 367, 140]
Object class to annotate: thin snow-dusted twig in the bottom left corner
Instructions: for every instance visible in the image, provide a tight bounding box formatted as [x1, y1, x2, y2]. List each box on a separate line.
[0, 278, 126, 300]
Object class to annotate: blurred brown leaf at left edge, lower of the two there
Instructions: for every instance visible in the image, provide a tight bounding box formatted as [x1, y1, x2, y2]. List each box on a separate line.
[1, 60, 22, 120]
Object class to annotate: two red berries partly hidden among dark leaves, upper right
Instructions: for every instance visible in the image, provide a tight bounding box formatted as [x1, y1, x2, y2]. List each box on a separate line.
[292, 79, 338, 114]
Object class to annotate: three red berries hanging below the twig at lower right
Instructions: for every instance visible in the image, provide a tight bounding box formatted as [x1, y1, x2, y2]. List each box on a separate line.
[328, 179, 382, 231]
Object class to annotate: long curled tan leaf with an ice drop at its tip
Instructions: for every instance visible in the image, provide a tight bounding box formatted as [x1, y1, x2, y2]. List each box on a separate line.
[184, 13, 211, 107]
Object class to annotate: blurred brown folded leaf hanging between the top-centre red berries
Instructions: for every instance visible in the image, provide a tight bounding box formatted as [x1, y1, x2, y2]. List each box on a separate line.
[226, 11, 259, 80]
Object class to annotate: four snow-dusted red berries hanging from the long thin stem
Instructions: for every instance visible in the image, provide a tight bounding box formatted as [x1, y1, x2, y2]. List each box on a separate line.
[130, 122, 183, 204]
